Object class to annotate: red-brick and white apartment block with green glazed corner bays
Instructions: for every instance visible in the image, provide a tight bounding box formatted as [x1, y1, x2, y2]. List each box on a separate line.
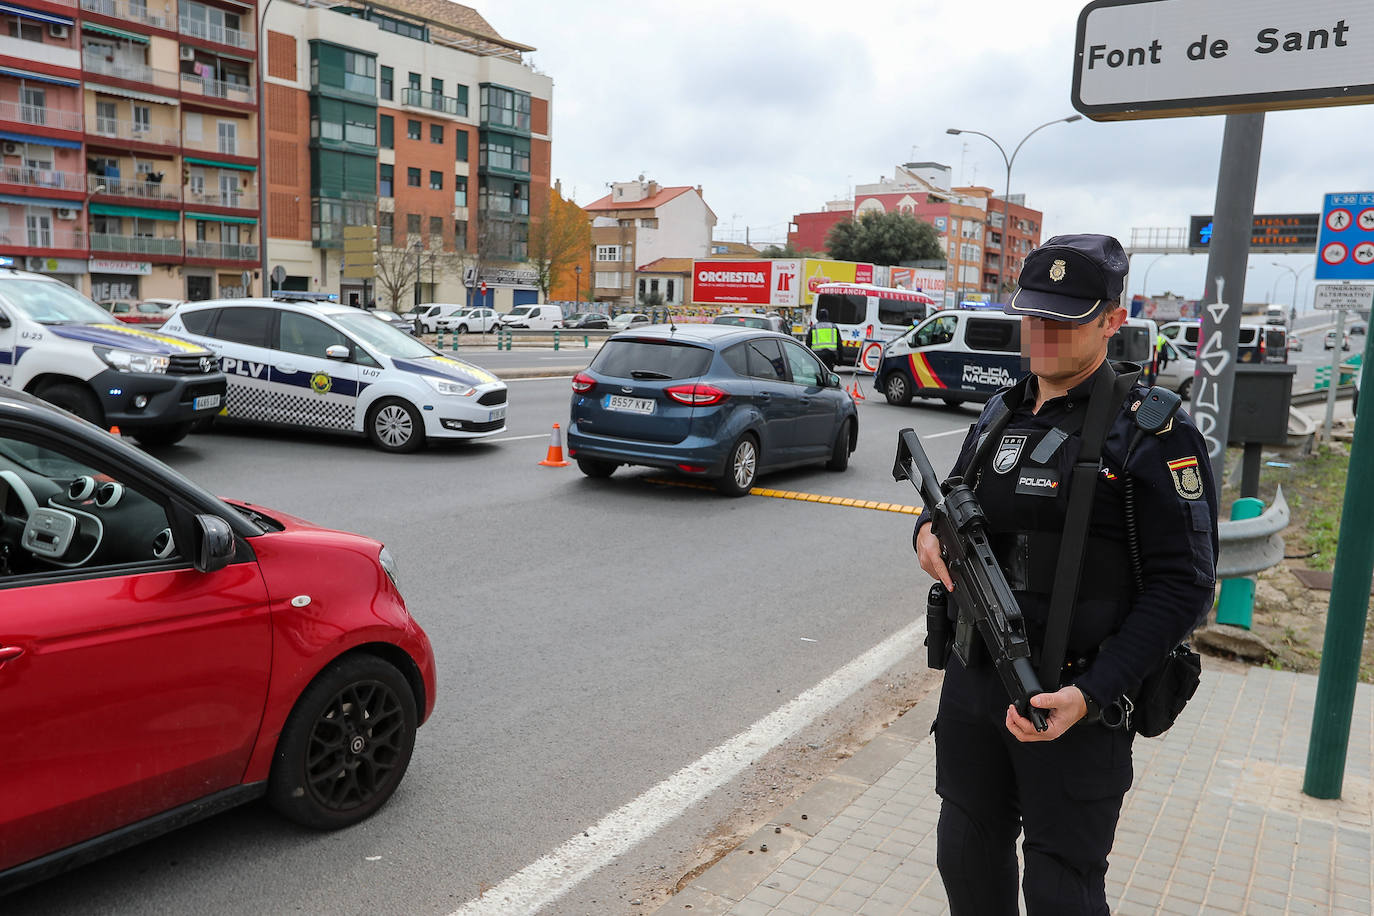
[264, 0, 552, 310]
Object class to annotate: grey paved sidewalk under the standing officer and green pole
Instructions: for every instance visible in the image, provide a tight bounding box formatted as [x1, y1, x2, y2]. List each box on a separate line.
[658, 658, 1374, 916]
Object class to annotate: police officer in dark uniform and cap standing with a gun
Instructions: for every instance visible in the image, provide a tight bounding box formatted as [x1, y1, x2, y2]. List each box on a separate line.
[915, 235, 1217, 916]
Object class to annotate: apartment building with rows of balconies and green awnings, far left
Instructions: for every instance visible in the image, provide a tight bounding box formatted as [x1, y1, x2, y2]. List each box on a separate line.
[0, 0, 261, 301]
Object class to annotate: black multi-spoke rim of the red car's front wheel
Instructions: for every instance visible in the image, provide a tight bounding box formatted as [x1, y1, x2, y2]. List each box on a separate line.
[305, 681, 405, 812]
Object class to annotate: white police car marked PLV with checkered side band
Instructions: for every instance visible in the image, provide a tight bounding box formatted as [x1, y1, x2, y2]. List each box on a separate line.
[162, 298, 507, 452]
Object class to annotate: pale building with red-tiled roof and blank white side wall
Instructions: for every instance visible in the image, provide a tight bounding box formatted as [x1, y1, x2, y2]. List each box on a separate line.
[583, 176, 716, 306]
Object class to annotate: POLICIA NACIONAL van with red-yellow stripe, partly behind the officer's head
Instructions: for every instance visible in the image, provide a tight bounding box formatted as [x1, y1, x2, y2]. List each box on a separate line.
[874, 305, 1156, 407]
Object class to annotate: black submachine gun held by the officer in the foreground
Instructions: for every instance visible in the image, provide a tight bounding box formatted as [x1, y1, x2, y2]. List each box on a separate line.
[892, 428, 1050, 732]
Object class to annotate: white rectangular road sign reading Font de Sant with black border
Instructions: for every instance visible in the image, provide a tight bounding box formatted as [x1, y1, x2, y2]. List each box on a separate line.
[1073, 0, 1374, 121]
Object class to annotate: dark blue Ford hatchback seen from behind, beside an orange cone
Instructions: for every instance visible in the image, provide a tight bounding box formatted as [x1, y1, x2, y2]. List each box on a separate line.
[567, 324, 859, 496]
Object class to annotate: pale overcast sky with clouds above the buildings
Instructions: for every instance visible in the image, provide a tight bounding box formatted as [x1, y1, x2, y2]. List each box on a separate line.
[489, 0, 1374, 311]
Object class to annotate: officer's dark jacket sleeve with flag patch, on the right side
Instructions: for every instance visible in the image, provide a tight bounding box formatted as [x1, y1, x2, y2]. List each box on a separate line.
[1077, 413, 1217, 703]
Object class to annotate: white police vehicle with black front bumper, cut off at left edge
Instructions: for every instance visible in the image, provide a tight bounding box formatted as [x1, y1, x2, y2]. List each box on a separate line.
[0, 269, 225, 445]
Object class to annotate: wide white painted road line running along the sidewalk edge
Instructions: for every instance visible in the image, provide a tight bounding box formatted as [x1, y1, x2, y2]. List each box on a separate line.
[451, 617, 926, 916]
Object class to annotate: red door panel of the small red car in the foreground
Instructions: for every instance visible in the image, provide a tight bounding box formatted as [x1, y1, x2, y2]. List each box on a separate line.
[0, 562, 271, 869]
